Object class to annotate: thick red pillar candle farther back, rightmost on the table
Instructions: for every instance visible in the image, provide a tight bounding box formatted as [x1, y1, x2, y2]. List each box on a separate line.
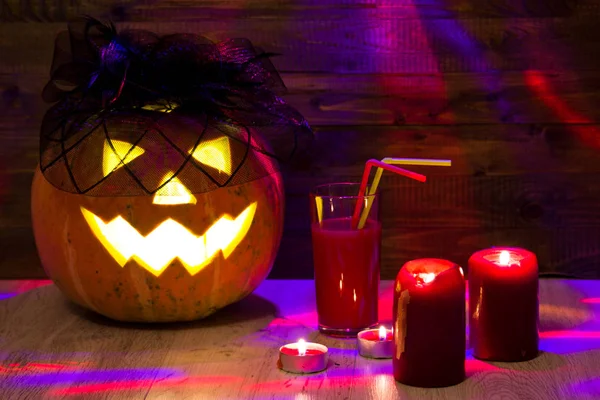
[469, 247, 539, 361]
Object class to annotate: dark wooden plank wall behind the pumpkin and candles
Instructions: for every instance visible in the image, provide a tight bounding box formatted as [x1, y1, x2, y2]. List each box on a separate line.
[0, 0, 600, 279]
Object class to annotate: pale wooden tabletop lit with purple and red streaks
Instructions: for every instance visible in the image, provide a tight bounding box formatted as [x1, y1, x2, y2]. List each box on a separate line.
[0, 280, 600, 400]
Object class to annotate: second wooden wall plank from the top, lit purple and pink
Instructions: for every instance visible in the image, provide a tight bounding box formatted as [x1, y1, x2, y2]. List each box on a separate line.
[0, 9, 600, 74]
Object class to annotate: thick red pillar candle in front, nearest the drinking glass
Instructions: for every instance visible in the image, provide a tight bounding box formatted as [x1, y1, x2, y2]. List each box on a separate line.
[393, 258, 466, 387]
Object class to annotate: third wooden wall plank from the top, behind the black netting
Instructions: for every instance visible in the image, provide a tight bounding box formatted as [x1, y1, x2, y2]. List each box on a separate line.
[5, 70, 600, 126]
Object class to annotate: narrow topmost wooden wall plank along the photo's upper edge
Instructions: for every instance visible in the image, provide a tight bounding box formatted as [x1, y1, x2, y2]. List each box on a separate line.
[0, 0, 598, 22]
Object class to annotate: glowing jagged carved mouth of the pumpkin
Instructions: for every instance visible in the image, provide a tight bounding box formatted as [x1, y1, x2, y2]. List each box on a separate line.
[81, 202, 257, 276]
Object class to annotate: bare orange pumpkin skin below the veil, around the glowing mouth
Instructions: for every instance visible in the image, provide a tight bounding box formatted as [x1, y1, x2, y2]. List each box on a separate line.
[32, 168, 284, 322]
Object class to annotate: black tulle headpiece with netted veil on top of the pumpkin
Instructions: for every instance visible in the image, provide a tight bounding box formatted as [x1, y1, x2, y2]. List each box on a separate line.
[40, 18, 312, 195]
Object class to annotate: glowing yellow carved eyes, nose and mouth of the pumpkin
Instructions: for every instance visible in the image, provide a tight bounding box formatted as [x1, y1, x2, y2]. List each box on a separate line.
[81, 137, 257, 276]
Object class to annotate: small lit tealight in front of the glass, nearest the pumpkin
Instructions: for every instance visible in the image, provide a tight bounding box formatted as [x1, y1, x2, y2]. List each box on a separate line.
[277, 339, 328, 374]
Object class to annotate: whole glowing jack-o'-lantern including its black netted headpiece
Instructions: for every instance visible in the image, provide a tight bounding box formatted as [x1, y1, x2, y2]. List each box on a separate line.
[32, 17, 313, 321]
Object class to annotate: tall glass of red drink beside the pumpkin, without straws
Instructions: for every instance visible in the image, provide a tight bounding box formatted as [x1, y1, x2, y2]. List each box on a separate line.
[311, 184, 381, 336]
